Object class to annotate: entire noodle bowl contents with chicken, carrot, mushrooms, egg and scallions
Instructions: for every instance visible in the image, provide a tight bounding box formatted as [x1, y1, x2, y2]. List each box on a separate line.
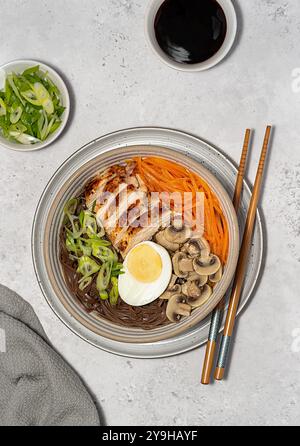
[60, 157, 229, 330]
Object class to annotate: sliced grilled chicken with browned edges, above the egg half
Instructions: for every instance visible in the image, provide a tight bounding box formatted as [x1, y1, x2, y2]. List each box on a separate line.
[86, 161, 176, 257]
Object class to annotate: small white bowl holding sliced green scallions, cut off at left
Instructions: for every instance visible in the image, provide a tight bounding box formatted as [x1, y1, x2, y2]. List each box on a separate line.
[0, 59, 70, 152]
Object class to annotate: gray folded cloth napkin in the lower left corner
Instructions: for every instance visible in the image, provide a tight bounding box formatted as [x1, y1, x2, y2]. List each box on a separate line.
[0, 285, 100, 426]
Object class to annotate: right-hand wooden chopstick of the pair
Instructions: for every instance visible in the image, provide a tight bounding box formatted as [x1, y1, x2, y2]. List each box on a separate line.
[215, 126, 272, 381]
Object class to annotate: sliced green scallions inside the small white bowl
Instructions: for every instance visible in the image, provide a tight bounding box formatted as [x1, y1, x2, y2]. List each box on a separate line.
[0, 65, 65, 144]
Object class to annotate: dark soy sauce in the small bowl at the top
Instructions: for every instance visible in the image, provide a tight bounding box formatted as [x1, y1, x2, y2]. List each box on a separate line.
[154, 0, 227, 64]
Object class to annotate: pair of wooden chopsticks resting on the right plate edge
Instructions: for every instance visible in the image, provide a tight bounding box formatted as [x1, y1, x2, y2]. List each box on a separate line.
[201, 126, 271, 384]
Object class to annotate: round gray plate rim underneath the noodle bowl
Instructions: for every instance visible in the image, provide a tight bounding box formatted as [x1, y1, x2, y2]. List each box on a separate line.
[32, 128, 263, 358]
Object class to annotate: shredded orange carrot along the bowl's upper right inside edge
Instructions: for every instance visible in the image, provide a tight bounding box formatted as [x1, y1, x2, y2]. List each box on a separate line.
[135, 157, 229, 264]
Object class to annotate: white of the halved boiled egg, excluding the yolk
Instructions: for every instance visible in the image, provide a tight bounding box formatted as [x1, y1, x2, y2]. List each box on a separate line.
[118, 242, 172, 307]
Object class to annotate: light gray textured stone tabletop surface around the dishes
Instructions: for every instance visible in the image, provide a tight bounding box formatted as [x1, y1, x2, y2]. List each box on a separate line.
[0, 0, 300, 425]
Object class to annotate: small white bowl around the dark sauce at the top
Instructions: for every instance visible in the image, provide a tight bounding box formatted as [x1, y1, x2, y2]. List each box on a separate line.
[145, 0, 237, 72]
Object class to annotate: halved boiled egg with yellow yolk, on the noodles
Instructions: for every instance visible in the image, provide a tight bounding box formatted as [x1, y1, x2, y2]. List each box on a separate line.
[119, 242, 172, 307]
